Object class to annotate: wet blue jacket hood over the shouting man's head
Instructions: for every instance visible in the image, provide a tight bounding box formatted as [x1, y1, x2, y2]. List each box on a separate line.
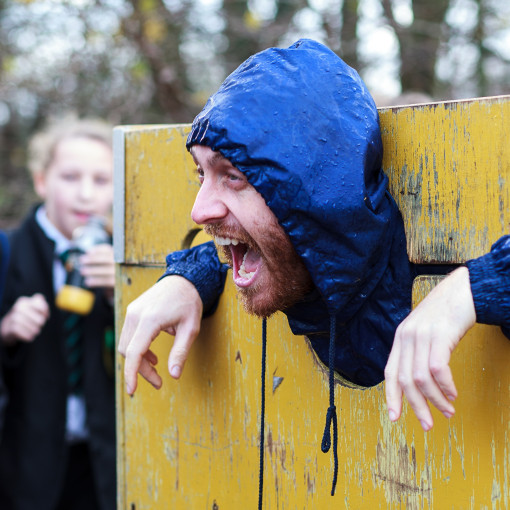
[187, 40, 398, 321]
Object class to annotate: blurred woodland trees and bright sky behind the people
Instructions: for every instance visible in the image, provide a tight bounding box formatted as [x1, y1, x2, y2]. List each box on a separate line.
[0, 0, 510, 228]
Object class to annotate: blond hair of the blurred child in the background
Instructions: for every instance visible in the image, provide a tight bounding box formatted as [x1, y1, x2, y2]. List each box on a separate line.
[28, 115, 112, 175]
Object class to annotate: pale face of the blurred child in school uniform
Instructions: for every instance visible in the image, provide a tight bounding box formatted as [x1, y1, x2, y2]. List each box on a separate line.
[34, 137, 113, 239]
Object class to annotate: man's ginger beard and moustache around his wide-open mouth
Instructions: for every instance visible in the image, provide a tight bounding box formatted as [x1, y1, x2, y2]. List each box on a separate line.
[204, 218, 313, 317]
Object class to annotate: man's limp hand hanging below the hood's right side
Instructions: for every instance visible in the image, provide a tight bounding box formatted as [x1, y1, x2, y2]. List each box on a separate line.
[384, 267, 476, 431]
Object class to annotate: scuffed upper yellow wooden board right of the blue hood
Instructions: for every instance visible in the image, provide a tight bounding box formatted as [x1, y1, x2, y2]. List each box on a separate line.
[381, 96, 510, 262]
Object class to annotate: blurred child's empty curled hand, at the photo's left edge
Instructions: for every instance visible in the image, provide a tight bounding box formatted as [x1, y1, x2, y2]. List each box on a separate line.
[0, 294, 50, 344]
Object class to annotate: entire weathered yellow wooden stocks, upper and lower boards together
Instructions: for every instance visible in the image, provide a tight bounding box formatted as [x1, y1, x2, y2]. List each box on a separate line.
[116, 98, 510, 510]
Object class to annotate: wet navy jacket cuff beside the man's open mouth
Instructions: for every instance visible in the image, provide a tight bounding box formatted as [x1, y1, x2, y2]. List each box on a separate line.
[162, 241, 228, 317]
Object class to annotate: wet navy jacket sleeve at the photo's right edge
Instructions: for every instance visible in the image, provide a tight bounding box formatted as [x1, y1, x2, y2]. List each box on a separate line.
[466, 236, 510, 336]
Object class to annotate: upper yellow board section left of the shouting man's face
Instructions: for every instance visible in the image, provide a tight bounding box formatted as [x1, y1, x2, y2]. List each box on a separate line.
[121, 126, 199, 264]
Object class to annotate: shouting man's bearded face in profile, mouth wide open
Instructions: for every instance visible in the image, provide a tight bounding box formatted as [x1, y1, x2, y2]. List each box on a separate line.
[191, 145, 313, 317]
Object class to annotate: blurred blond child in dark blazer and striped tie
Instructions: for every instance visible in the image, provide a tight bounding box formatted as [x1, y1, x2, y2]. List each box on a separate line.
[0, 119, 116, 510]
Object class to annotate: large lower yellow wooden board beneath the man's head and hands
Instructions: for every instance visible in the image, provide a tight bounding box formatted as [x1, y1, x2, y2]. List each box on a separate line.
[119, 267, 510, 510]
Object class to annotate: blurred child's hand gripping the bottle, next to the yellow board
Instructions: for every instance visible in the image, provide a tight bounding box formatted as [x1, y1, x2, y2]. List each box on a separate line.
[80, 244, 115, 291]
